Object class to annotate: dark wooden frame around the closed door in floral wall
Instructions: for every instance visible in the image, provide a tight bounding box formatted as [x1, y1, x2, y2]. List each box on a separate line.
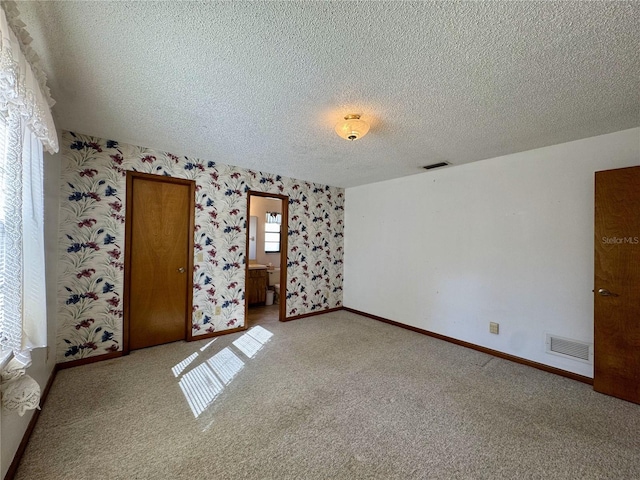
[122, 170, 196, 355]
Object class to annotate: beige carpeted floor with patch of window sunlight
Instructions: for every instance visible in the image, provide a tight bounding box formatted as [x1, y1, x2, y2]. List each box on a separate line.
[16, 312, 640, 480]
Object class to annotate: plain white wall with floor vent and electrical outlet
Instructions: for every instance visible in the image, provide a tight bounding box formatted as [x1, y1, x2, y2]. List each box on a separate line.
[344, 128, 640, 377]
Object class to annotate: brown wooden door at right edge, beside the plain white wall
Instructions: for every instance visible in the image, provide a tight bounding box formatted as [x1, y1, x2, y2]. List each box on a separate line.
[593, 167, 640, 403]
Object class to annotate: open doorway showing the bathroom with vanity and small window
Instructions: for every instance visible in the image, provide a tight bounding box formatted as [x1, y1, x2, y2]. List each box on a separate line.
[245, 190, 289, 328]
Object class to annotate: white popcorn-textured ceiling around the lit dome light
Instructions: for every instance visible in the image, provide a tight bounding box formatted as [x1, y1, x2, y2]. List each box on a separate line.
[17, 1, 640, 187]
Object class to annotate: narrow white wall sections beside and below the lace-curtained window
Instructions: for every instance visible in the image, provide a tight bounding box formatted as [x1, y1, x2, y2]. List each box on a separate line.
[0, 149, 60, 478]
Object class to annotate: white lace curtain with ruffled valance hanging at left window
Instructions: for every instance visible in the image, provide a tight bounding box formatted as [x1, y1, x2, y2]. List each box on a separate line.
[0, 2, 58, 365]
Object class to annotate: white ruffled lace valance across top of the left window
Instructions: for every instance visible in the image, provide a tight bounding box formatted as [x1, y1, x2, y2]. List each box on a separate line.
[0, 2, 58, 153]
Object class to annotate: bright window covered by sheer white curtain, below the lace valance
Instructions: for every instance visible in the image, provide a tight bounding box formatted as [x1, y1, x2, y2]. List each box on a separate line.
[0, 118, 47, 363]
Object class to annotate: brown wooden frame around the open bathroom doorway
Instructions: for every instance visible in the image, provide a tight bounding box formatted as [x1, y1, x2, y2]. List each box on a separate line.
[244, 190, 289, 322]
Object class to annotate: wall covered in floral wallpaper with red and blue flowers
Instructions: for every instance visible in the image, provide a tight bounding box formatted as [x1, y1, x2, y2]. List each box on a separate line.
[57, 132, 344, 362]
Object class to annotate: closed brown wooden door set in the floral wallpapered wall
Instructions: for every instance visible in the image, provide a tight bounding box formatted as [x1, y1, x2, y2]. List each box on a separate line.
[125, 172, 194, 350]
